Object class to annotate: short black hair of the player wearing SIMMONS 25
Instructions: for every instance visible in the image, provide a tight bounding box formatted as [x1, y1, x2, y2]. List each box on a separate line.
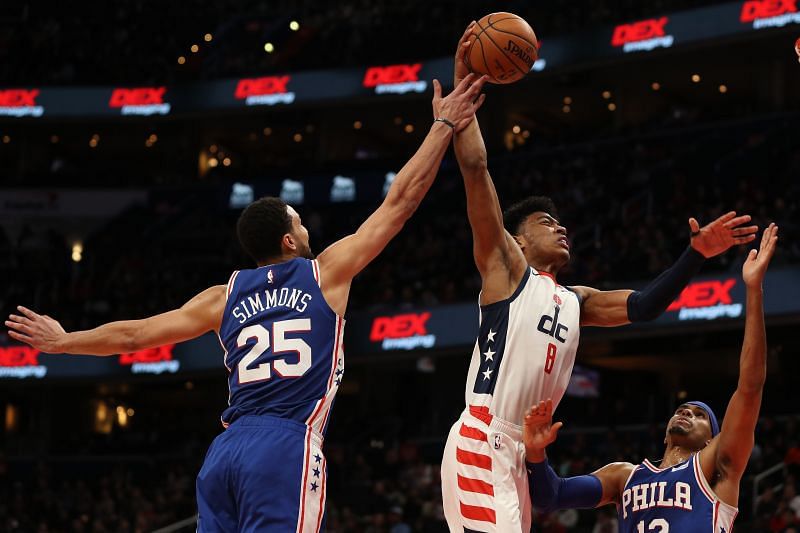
[236, 196, 292, 263]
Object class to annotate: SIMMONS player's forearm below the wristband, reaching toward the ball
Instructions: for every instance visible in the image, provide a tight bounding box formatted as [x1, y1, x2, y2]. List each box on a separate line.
[386, 122, 453, 217]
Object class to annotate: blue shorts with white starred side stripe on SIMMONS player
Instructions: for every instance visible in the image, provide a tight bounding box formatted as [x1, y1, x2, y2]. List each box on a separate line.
[197, 416, 327, 533]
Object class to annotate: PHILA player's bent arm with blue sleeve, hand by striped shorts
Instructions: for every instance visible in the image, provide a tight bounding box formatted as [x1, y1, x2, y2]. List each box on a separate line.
[522, 399, 635, 511]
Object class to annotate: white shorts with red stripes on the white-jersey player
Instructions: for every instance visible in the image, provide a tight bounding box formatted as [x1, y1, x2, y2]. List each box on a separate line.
[442, 406, 531, 533]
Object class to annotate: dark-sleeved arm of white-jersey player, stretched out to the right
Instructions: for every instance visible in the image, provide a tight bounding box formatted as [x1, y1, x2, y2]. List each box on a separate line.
[573, 211, 758, 326]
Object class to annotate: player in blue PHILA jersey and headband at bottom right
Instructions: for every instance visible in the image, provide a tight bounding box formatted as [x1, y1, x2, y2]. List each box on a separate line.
[524, 224, 778, 533]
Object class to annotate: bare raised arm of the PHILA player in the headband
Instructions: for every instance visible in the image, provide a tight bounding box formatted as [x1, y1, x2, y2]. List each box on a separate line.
[700, 224, 778, 506]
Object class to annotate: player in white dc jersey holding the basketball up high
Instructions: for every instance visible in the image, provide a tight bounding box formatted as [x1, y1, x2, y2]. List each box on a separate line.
[442, 23, 758, 533]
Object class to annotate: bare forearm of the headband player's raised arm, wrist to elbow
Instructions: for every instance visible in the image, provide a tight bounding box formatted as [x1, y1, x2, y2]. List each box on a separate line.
[737, 286, 767, 394]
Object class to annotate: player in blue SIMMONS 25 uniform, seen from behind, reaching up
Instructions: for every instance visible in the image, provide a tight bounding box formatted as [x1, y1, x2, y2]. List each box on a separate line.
[6, 72, 486, 533]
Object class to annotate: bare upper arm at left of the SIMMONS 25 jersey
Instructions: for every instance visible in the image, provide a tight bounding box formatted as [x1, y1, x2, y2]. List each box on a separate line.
[135, 285, 226, 349]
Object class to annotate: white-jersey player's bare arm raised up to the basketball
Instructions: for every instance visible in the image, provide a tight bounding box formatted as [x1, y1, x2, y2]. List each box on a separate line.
[453, 22, 527, 303]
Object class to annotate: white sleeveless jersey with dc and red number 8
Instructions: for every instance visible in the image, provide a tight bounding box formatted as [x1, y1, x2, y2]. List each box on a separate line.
[466, 267, 581, 425]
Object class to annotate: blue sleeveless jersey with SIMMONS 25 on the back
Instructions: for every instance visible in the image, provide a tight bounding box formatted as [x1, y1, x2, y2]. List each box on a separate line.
[219, 258, 344, 435]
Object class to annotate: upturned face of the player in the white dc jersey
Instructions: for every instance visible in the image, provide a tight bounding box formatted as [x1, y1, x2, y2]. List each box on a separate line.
[519, 211, 569, 268]
